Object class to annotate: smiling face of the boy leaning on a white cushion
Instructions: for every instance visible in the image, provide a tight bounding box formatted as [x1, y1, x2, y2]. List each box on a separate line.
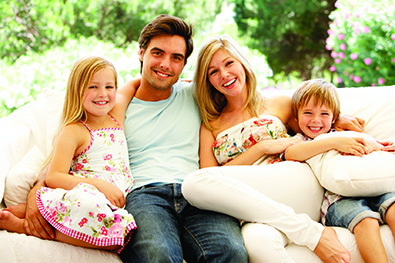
[298, 98, 333, 139]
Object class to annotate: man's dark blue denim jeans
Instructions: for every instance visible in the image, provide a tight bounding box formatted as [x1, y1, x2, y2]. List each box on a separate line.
[121, 184, 247, 263]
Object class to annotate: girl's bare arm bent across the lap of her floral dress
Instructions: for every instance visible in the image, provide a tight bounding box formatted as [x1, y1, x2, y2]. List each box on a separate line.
[45, 124, 125, 207]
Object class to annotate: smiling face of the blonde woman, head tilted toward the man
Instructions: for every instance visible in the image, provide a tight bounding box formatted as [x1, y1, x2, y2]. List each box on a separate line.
[207, 48, 246, 97]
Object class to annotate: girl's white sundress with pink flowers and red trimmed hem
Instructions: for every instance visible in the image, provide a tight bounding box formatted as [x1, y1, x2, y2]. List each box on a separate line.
[36, 116, 136, 253]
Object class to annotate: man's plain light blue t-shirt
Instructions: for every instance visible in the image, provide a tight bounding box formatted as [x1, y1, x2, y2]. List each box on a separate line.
[125, 81, 201, 188]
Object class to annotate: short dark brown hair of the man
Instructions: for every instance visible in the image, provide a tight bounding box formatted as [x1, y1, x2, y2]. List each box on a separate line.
[139, 15, 193, 68]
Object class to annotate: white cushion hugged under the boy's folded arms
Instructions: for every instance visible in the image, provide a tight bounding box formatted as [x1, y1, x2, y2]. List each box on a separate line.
[307, 131, 395, 196]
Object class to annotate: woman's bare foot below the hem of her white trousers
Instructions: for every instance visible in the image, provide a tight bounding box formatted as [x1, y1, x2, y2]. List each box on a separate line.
[314, 227, 351, 263]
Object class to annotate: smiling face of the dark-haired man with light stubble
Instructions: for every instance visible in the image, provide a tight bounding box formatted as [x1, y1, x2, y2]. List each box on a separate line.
[139, 35, 186, 95]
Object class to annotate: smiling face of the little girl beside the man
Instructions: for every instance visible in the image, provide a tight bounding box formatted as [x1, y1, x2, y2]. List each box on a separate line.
[83, 68, 116, 117]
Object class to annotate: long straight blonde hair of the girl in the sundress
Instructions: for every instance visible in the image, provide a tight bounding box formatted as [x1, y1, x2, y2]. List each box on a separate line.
[61, 56, 118, 128]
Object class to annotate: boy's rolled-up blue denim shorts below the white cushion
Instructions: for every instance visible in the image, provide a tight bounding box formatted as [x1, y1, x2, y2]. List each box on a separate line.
[325, 193, 395, 232]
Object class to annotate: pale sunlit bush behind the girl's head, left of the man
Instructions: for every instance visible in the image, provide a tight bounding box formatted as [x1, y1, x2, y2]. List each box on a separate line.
[0, 37, 140, 117]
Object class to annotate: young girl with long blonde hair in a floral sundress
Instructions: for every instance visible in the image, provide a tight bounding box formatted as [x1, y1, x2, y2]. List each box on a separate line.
[0, 57, 136, 252]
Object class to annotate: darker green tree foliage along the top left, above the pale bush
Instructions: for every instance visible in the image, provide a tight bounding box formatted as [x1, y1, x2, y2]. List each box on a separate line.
[0, 0, 221, 63]
